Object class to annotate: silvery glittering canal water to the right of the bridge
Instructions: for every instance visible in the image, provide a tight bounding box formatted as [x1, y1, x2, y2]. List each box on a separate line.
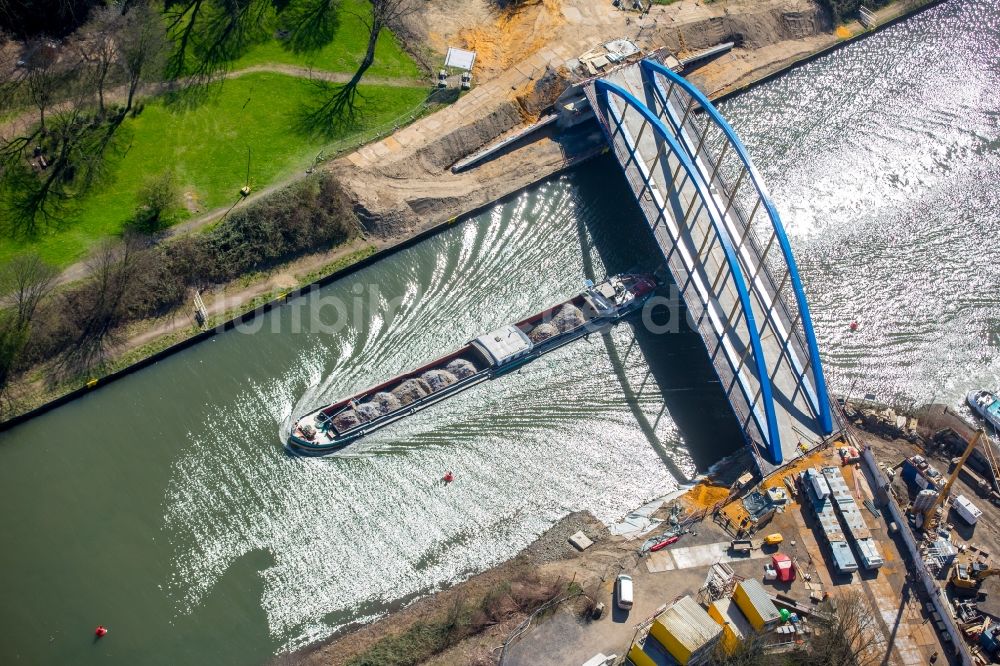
[722, 0, 1000, 406]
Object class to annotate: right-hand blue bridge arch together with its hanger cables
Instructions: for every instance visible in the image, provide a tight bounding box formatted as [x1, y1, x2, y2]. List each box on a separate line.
[640, 60, 833, 434]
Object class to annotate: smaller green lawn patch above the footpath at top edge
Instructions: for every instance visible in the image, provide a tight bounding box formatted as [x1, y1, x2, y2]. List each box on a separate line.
[232, 0, 425, 79]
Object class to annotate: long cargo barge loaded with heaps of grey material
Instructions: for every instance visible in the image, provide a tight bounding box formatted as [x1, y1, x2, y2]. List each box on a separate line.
[286, 274, 656, 456]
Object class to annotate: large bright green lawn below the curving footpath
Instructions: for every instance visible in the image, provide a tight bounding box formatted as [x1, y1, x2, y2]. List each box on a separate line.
[0, 73, 428, 266]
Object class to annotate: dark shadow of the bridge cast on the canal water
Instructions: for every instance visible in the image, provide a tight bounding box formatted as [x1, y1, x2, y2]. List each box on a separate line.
[573, 155, 744, 479]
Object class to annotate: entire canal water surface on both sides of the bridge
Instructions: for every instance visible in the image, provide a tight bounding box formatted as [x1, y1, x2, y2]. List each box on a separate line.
[0, 0, 1000, 664]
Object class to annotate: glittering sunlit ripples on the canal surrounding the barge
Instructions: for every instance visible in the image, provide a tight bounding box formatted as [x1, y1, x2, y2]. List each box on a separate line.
[165, 179, 691, 649]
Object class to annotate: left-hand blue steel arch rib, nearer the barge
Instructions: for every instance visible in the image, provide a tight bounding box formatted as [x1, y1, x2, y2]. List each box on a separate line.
[594, 79, 784, 464]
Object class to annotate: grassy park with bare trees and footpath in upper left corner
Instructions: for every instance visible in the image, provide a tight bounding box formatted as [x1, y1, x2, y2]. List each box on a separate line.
[0, 0, 428, 266]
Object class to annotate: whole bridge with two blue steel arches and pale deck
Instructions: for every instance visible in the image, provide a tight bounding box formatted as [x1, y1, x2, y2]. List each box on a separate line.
[586, 58, 842, 473]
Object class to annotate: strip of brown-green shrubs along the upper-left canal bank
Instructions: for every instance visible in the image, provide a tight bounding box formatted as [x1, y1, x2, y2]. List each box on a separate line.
[0, 173, 357, 418]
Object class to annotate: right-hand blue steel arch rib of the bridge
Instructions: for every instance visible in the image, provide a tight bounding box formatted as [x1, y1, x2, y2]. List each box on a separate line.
[639, 59, 833, 435]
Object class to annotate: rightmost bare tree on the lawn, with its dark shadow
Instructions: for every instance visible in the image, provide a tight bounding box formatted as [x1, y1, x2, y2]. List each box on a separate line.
[304, 0, 416, 129]
